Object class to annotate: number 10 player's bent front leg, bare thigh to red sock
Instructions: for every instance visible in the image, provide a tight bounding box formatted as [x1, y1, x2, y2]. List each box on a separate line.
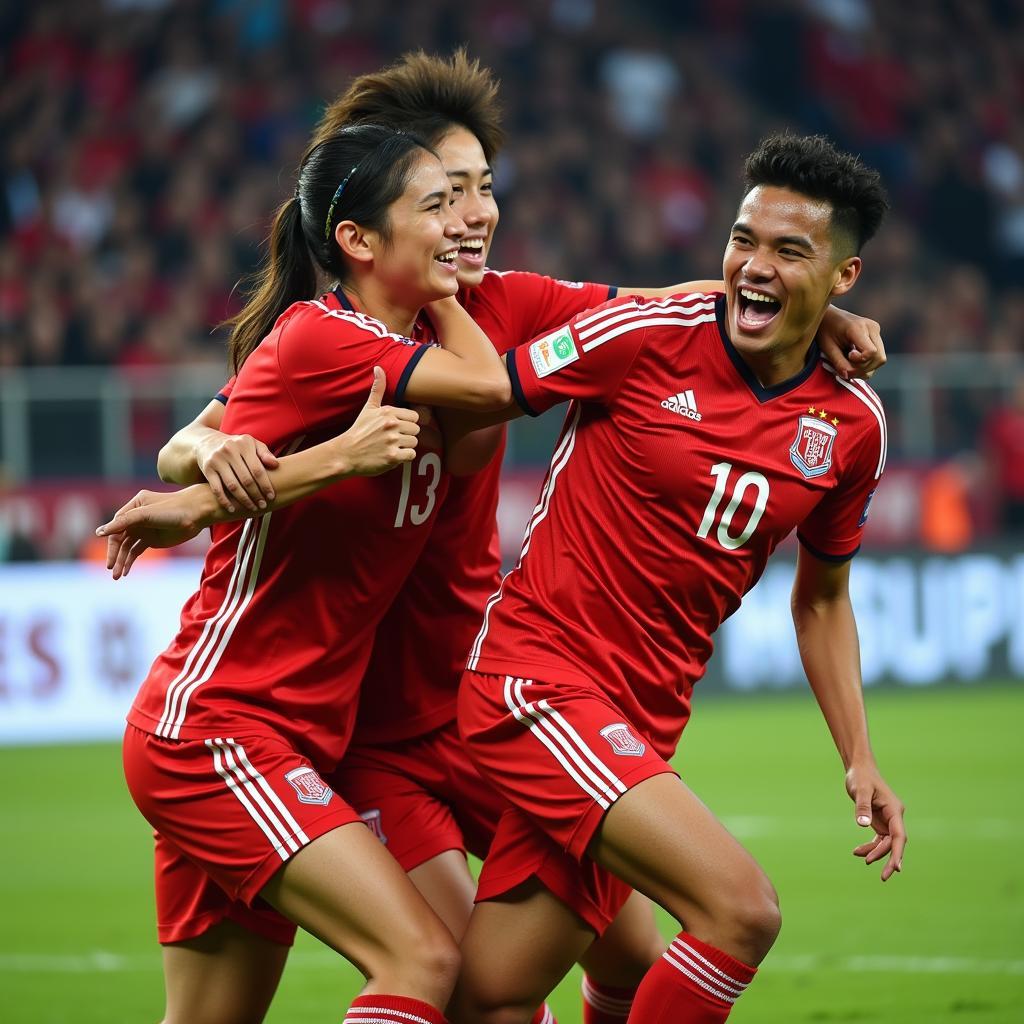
[588, 775, 781, 1024]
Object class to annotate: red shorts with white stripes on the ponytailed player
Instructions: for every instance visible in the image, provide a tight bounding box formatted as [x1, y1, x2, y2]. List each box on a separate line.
[124, 725, 359, 942]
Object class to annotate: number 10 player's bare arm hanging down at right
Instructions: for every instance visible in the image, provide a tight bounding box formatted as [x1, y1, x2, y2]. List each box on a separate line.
[792, 545, 906, 882]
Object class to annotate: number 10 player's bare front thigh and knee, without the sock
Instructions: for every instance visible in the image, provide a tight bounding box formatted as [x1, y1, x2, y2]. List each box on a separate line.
[589, 775, 778, 958]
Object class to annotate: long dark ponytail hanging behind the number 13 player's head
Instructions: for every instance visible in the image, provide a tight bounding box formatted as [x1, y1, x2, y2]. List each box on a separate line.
[224, 199, 317, 373]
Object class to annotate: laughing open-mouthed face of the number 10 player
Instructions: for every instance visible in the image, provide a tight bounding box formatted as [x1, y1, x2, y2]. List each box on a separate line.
[722, 185, 860, 387]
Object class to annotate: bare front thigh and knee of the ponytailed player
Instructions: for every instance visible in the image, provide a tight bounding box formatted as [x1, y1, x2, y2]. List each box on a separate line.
[261, 823, 458, 990]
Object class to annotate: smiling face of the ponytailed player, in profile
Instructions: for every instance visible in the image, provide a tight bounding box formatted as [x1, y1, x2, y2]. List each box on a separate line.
[335, 151, 466, 308]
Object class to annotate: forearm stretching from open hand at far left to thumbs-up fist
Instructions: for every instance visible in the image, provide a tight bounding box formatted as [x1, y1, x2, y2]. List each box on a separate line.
[96, 367, 420, 580]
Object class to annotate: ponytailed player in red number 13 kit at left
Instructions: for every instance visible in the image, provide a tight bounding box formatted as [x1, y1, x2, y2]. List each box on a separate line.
[117, 126, 520, 1024]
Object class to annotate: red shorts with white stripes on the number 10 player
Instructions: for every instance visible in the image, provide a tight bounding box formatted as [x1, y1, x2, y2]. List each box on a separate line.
[459, 672, 675, 934]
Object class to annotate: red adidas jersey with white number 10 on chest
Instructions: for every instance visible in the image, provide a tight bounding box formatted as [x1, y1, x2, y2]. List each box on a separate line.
[467, 294, 886, 758]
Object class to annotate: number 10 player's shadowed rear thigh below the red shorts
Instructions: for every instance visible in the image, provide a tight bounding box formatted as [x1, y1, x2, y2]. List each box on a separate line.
[449, 879, 594, 1024]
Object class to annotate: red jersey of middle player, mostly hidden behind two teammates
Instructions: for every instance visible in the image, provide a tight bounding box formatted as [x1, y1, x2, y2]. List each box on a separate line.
[355, 270, 614, 743]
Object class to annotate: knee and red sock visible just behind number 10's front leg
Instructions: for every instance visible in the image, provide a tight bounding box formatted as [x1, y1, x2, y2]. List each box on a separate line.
[580, 891, 665, 1024]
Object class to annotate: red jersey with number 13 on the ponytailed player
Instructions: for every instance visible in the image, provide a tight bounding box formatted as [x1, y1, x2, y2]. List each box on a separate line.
[129, 294, 446, 770]
